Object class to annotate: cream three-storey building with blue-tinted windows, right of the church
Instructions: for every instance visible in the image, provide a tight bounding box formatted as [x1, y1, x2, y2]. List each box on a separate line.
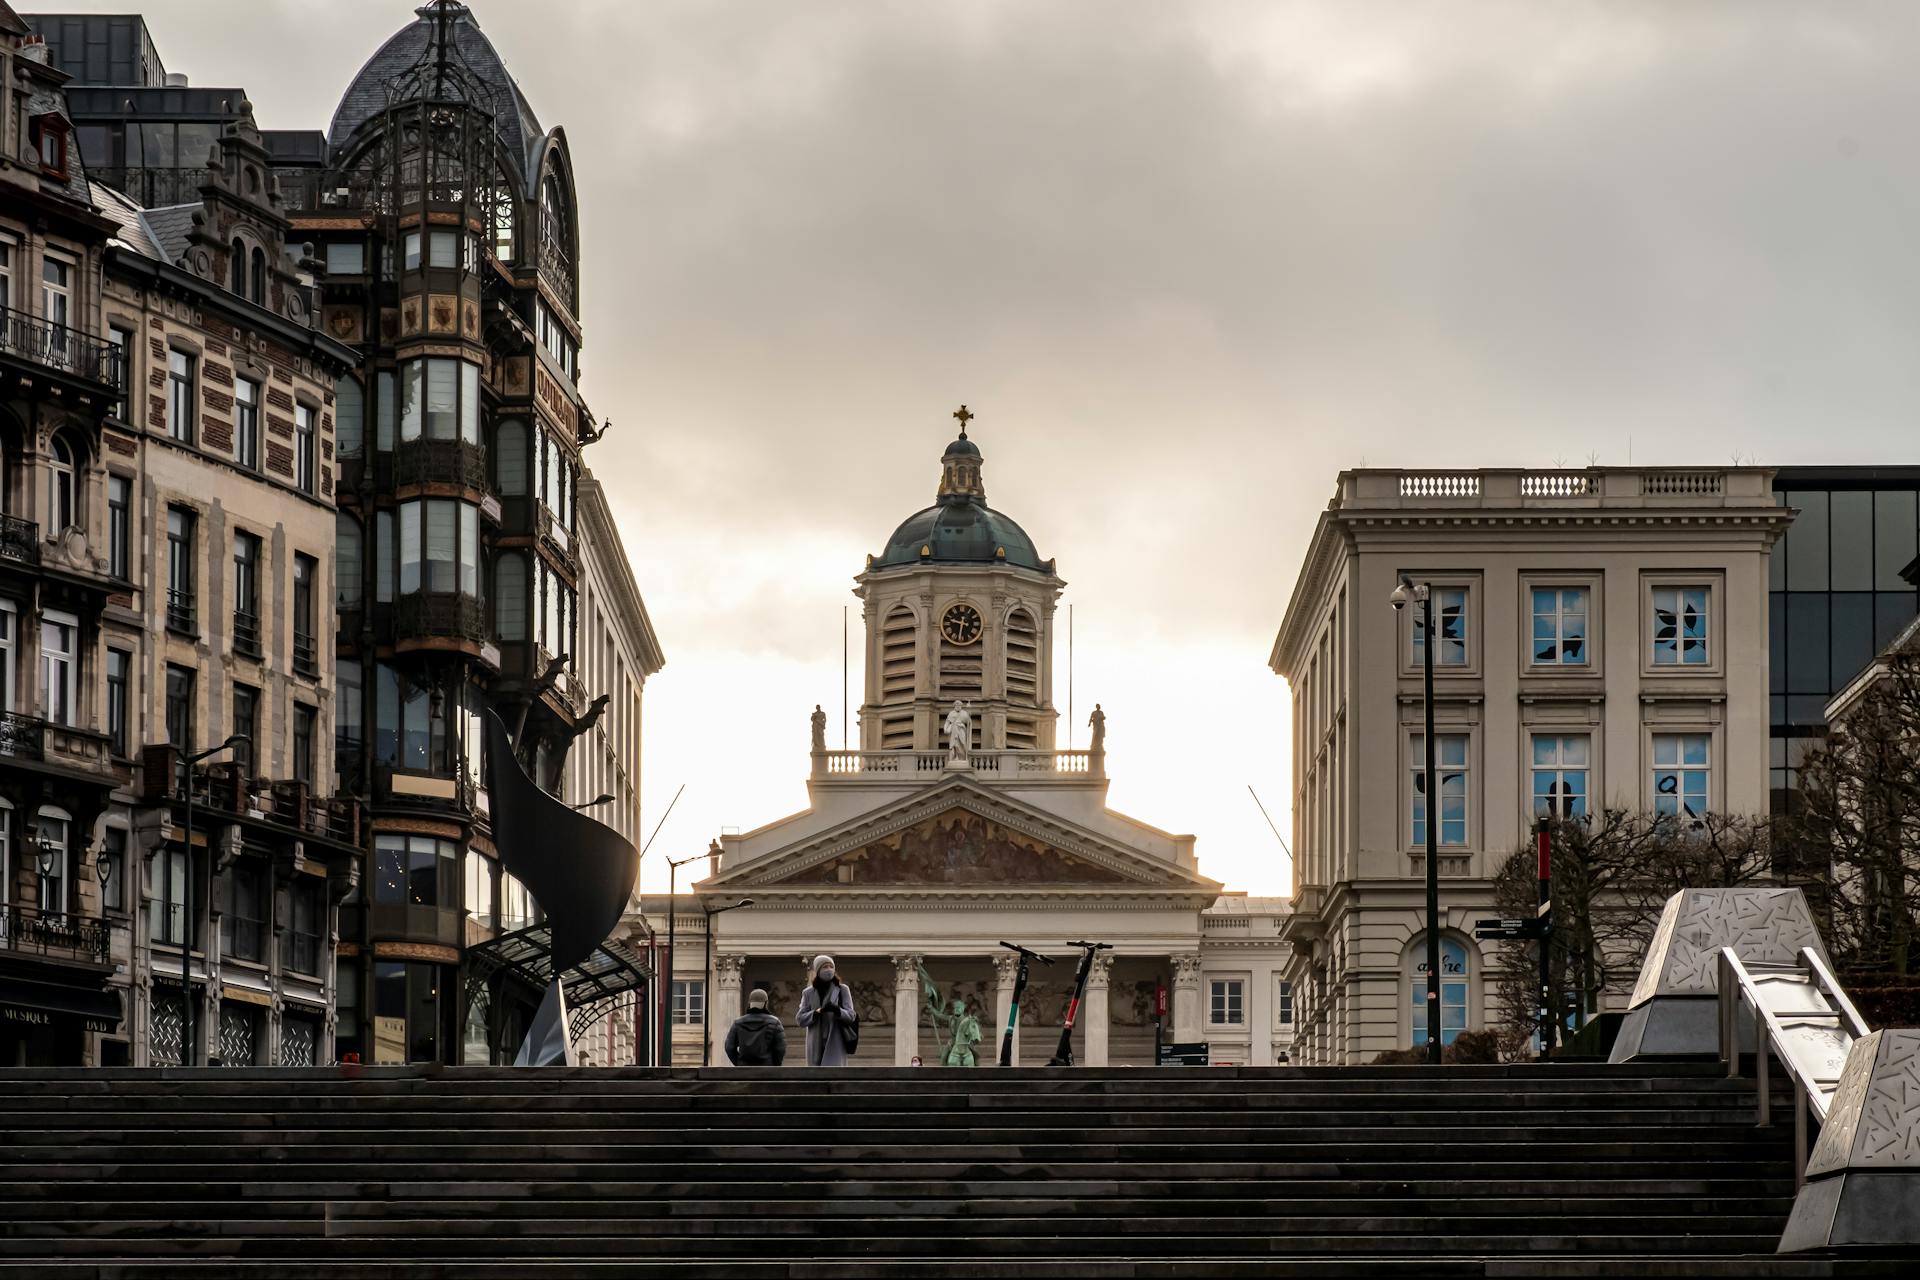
[1271, 466, 1791, 1063]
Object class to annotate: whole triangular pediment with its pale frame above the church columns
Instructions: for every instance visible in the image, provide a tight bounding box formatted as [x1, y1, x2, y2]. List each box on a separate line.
[699, 783, 1219, 892]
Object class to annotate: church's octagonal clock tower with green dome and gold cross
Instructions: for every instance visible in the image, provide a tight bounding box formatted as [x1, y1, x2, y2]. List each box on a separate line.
[854, 405, 1066, 750]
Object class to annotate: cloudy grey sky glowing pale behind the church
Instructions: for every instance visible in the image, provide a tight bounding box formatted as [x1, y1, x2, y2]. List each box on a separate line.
[67, 0, 1920, 894]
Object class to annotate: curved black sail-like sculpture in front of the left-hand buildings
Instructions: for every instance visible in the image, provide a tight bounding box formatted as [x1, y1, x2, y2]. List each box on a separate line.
[486, 710, 639, 977]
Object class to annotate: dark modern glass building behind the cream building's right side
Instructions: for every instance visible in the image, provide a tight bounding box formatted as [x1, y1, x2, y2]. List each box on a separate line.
[1768, 466, 1920, 812]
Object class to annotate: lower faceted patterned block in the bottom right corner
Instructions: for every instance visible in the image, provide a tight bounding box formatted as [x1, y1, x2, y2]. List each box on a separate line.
[1780, 1027, 1920, 1253]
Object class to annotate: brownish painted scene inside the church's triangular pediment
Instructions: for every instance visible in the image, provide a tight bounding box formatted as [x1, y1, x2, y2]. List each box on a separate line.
[780, 810, 1139, 889]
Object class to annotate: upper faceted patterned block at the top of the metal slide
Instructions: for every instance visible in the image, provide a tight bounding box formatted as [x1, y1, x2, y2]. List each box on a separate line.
[1611, 889, 1845, 1079]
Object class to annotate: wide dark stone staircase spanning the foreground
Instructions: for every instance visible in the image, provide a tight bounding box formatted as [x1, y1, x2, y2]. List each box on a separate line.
[0, 1063, 1914, 1280]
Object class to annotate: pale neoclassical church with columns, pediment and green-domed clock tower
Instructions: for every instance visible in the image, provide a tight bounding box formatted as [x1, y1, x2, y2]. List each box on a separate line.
[674, 405, 1292, 1067]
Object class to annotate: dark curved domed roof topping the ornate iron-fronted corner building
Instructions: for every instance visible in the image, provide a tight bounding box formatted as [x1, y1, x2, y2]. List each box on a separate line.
[326, 4, 545, 177]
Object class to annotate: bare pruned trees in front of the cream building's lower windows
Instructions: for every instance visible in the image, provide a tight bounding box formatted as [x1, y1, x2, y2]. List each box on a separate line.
[1494, 810, 1772, 1040]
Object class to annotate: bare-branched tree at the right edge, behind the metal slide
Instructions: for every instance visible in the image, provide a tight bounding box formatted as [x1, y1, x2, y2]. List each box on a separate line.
[1778, 631, 1920, 975]
